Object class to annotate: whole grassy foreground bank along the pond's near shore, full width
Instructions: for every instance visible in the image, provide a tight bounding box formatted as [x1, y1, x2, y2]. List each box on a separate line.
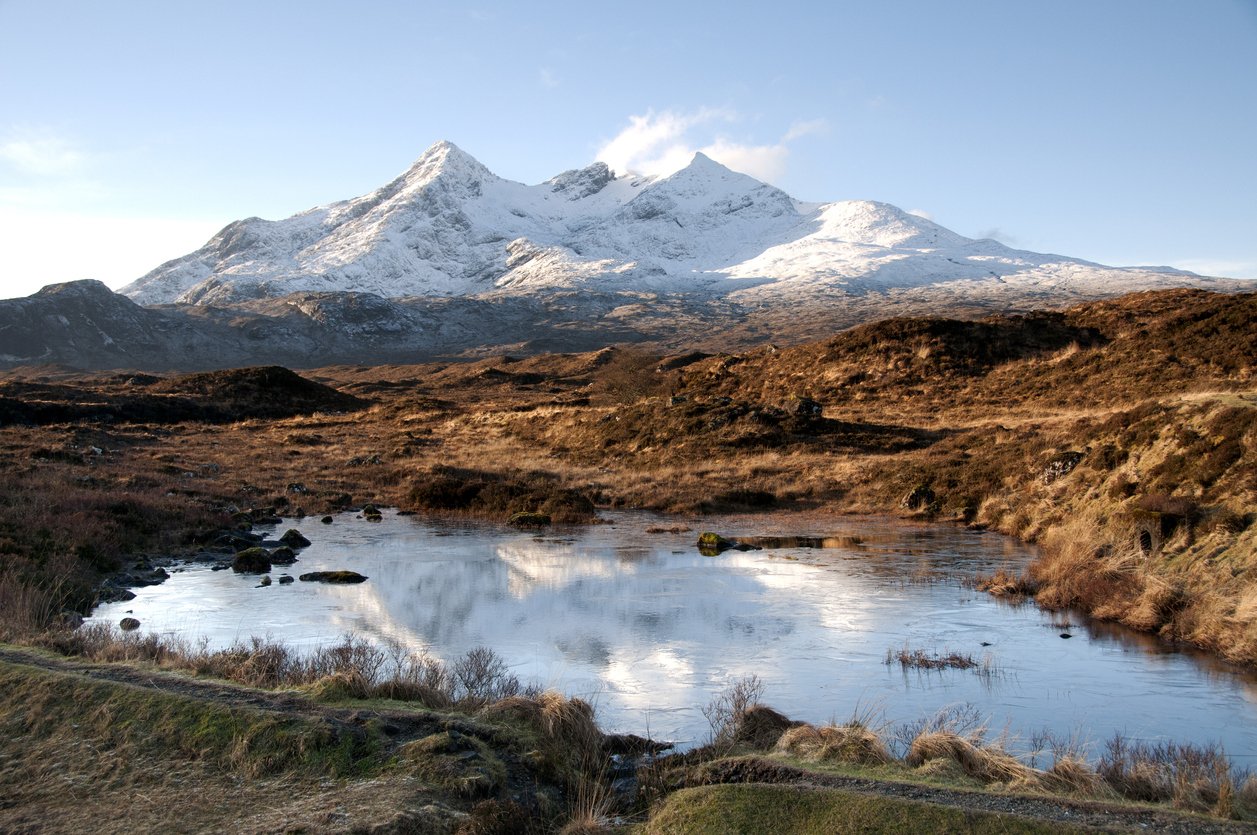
[0, 635, 1257, 835]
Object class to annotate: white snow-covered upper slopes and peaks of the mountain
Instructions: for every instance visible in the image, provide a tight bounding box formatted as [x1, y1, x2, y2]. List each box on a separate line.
[121, 142, 1211, 306]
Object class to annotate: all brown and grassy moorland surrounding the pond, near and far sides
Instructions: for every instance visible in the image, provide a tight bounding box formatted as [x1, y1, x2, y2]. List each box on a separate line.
[0, 285, 1257, 831]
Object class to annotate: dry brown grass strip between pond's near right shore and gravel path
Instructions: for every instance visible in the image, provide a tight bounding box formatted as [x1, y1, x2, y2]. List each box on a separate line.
[644, 679, 1257, 826]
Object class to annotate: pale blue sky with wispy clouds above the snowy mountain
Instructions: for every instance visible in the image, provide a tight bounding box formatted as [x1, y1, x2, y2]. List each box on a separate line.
[0, 0, 1257, 297]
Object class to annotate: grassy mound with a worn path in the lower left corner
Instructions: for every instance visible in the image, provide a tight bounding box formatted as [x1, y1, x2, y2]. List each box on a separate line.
[0, 646, 613, 832]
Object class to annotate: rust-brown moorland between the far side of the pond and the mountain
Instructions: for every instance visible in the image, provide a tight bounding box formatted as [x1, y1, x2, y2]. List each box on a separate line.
[0, 290, 1257, 661]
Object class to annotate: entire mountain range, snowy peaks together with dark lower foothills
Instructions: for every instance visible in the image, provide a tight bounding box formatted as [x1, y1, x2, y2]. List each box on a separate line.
[0, 142, 1252, 370]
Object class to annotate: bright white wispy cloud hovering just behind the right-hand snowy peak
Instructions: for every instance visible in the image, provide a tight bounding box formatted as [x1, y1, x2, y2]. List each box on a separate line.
[597, 107, 828, 182]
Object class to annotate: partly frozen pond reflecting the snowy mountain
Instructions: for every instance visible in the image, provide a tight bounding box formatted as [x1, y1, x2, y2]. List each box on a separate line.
[96, 513, 1257, 763]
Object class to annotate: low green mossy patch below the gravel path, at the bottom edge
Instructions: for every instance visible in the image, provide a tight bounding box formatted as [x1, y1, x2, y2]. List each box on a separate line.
[639, 785, 1081, 835]
